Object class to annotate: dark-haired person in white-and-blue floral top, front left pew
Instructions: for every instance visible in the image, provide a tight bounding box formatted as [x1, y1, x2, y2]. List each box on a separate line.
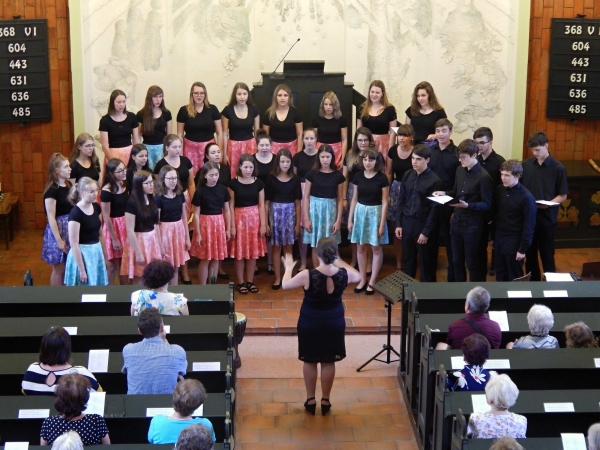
[131, 259, 190, 316]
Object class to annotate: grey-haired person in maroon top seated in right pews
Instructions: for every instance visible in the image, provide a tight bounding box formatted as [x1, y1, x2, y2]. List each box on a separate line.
[436, 286, 502, 350]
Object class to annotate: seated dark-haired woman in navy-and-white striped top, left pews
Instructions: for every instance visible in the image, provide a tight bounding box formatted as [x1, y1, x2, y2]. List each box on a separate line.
[21, 327, 102, 395]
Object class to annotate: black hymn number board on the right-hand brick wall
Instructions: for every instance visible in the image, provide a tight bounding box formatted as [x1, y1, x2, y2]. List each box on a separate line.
[546, 19, 600, 119]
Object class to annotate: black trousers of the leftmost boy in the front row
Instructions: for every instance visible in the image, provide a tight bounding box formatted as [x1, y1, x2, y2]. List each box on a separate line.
[402, 217, 438, 282]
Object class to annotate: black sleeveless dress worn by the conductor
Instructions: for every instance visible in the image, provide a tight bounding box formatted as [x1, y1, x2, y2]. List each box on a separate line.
[298, 269, 348, 363]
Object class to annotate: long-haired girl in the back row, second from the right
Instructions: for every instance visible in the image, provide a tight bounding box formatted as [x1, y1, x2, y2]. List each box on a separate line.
[356, 80, 398, 161]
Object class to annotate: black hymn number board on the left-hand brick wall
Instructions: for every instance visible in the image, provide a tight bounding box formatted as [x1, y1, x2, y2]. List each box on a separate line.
[0, 19, 52, 122]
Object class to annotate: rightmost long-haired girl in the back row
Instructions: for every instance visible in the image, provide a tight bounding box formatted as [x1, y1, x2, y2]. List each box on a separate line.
[405, 81, 447, 145]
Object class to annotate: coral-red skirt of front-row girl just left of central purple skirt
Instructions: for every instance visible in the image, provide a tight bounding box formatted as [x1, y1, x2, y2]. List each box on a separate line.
[229, 205, 267, 259]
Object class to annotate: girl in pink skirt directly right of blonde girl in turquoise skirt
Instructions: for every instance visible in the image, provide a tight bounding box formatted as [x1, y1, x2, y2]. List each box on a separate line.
[100, 158, 129, 286]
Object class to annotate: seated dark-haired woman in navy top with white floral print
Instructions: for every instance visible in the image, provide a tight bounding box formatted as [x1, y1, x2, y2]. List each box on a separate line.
[447, 333, 491, 391]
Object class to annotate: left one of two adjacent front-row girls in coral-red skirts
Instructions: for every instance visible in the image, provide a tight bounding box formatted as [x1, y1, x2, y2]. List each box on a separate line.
[190, 163, 232, 284]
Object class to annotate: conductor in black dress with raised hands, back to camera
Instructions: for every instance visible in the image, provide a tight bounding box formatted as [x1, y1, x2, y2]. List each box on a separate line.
[281, 238, 360, 416]
